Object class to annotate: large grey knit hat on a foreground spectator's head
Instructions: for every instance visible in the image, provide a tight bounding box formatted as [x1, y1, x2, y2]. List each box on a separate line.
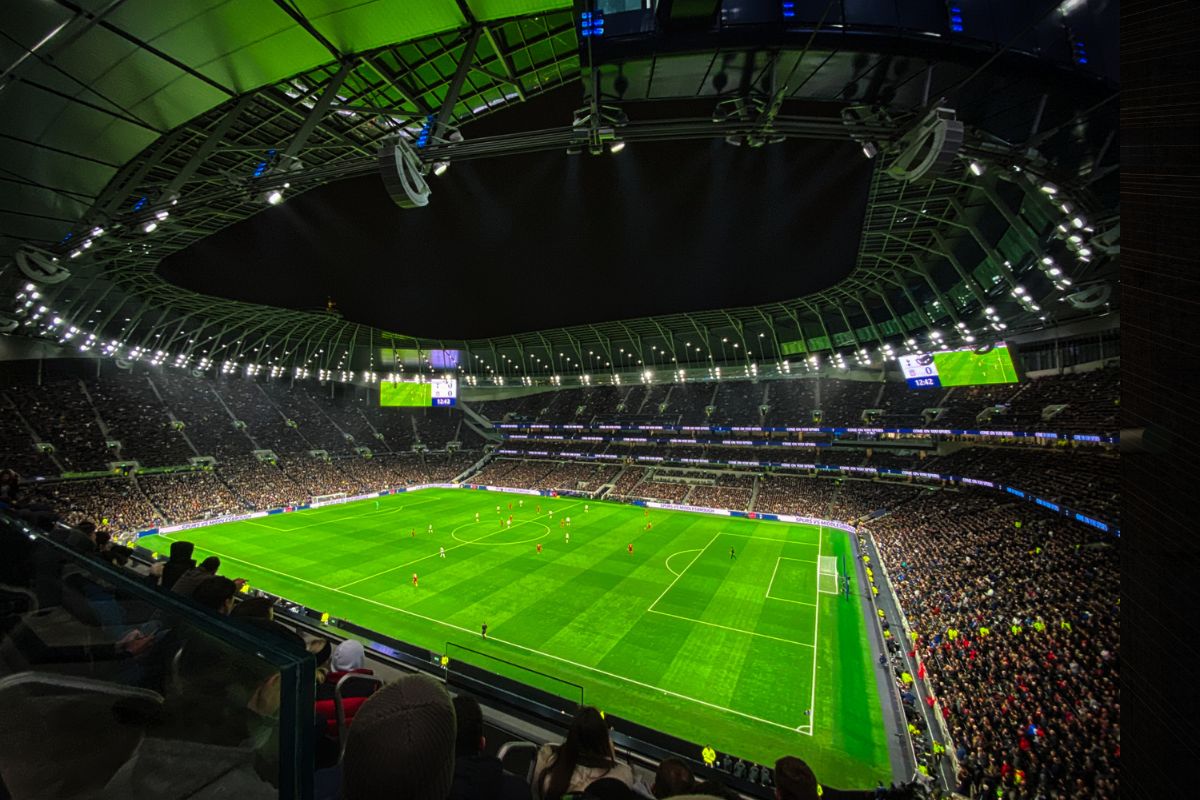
[342, 675, 456, 800]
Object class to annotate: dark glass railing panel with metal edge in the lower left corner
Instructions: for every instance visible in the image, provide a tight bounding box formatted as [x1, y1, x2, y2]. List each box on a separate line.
[0, 511, 314, 800]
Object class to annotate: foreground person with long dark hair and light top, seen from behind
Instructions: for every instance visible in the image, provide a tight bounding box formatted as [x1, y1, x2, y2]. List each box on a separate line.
[533, 706, 634, 800]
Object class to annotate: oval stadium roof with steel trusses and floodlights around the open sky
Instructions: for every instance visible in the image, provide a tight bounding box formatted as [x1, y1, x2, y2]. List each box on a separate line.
[0, 0, 1120, 377]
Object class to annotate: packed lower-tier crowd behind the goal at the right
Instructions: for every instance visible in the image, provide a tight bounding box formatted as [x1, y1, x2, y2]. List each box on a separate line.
[869, 492, 1121, 799]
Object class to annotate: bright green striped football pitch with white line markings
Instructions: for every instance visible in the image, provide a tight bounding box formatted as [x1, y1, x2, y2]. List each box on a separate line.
[138, 489, 892, 788]
